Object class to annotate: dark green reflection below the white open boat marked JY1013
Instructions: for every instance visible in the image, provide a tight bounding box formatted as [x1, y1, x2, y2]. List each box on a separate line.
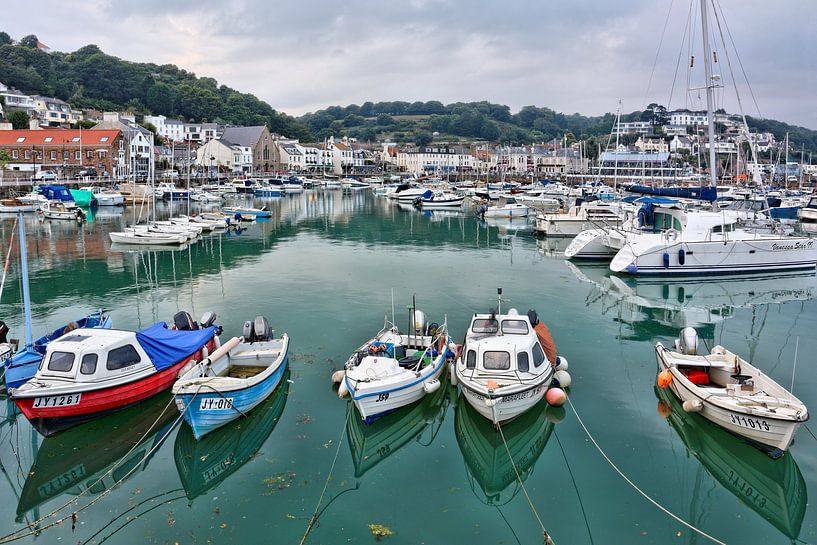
[655, 387, 807, 539]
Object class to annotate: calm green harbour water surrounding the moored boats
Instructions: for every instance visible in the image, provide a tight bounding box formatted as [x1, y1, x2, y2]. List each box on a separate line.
[0, 192, 817, 545]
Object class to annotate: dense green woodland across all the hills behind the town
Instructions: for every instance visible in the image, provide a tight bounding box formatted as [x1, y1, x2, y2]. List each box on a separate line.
[0, 32, 817, 158]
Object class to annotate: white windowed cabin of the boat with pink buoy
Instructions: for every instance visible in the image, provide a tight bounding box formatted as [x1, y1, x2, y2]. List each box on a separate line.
[462, 309, 550, 376]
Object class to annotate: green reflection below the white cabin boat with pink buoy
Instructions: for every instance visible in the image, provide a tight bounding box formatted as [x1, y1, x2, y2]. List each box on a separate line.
[454, 398, 564, 506]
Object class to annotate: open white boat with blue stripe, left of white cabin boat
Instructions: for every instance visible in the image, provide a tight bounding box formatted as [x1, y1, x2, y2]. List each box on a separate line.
[333, 304, 451, 423]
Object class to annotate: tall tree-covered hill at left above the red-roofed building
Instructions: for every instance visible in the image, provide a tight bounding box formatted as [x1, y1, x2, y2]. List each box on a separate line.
[0, 32, 309, 139]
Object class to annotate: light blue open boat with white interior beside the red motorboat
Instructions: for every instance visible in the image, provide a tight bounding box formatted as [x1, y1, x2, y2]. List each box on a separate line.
[173, 316, 289, 439]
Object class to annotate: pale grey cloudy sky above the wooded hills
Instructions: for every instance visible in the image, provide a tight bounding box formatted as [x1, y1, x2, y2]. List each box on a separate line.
[6, 0, 817, 129]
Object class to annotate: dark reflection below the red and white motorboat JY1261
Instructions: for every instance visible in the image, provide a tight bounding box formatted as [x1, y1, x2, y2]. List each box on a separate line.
[17, 394, 178, 522]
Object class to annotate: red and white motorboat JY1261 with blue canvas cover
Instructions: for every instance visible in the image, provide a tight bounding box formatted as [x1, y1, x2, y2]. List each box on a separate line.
[9, 313, 219, 436]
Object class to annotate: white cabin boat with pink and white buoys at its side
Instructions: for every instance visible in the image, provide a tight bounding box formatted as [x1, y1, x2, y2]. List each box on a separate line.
[451, 288, 557, 424]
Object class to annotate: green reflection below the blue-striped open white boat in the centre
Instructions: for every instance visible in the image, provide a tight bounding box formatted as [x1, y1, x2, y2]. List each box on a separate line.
[346, 378, 455, 478]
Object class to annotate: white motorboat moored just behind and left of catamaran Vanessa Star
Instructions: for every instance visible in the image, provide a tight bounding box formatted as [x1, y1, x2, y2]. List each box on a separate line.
[534, 201, 631, 237]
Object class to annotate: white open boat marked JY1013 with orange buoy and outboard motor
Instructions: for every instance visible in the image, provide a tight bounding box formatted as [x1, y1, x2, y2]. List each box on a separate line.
[655, 327, 809, 457]
